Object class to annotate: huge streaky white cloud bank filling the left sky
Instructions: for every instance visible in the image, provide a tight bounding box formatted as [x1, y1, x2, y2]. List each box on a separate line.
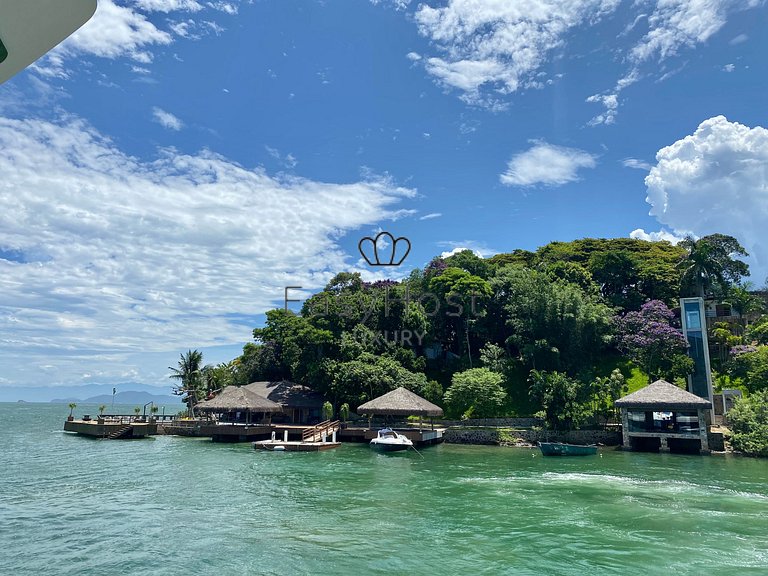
[0, 117, 415, 383]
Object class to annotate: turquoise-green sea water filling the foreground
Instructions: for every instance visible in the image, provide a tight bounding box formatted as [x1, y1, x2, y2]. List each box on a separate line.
[0, 404, 768, 576]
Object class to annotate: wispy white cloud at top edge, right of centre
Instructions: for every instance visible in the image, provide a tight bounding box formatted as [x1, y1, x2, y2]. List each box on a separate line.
[415, 0, 618, 104]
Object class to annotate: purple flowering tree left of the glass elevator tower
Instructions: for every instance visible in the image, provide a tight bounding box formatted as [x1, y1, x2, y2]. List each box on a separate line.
[614, 300, 693, 382]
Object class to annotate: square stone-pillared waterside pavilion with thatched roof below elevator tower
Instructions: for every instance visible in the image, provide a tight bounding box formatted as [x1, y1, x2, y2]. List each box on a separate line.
[616, 380, 712, 454]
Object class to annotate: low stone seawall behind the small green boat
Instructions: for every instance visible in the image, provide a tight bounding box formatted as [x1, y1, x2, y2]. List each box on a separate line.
[443, 427, 621, 446]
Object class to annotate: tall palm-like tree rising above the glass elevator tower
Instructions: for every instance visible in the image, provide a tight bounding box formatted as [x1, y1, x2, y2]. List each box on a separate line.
[678, 234, 749, 298]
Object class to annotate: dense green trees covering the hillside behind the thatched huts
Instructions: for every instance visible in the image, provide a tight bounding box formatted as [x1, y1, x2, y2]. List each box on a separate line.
[172, 234, 768, 428]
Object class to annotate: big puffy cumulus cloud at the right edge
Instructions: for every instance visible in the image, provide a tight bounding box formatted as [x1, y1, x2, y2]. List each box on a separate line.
[645, 116, 768, 280]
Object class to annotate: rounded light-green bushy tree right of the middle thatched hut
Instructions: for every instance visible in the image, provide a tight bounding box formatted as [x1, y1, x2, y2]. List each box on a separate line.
[444, 368, 507, 418]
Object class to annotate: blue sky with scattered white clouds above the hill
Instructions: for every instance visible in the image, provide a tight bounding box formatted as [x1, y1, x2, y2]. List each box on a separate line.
[0, 0, 768, 400]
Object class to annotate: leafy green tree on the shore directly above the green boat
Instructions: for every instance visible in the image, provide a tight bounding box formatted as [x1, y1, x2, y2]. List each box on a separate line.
[530, 370, 591, 430]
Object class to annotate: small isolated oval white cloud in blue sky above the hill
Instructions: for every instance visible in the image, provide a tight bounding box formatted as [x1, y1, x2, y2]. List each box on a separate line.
[499, 142, 597, 186]
